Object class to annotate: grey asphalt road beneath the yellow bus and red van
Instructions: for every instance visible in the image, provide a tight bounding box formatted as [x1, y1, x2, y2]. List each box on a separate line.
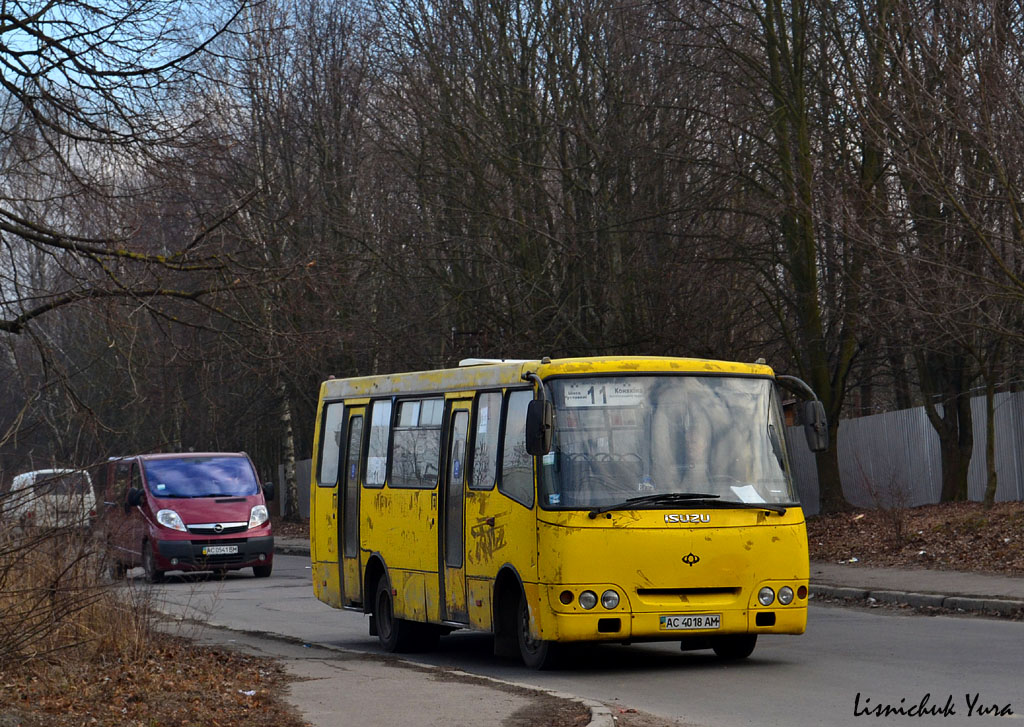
[154, 555, 1024, 727]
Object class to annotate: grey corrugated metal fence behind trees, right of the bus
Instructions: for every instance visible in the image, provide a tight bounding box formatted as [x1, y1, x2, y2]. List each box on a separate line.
[790, 392, 1024, 515]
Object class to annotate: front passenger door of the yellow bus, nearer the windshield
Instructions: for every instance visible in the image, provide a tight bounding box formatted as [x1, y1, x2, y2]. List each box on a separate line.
[440, 399, 473, 624]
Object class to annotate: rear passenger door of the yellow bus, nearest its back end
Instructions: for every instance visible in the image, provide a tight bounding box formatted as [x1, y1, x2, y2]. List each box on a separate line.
[338, 407, 366, 605]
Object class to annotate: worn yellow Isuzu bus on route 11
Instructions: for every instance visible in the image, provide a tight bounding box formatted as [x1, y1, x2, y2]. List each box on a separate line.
[309, 356, 824, 669]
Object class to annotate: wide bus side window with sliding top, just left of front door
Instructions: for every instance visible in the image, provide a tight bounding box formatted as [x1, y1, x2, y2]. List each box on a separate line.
[388, 398, 444, 488]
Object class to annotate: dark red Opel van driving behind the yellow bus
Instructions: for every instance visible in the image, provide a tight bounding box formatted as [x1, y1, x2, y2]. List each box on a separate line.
[103, 452, 273, 583]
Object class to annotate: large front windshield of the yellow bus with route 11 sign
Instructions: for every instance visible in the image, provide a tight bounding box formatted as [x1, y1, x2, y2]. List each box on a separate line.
[539, 375, 797, 509]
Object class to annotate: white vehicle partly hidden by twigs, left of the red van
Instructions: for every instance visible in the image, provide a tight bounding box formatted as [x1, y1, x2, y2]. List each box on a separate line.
[3, 469, 96, 527]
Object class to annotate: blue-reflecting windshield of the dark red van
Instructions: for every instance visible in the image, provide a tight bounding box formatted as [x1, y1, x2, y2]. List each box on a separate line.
[142, 457, 259, 498]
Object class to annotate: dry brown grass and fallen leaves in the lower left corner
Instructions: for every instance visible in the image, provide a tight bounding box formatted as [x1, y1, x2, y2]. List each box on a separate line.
[0, 530, 305, 727]
